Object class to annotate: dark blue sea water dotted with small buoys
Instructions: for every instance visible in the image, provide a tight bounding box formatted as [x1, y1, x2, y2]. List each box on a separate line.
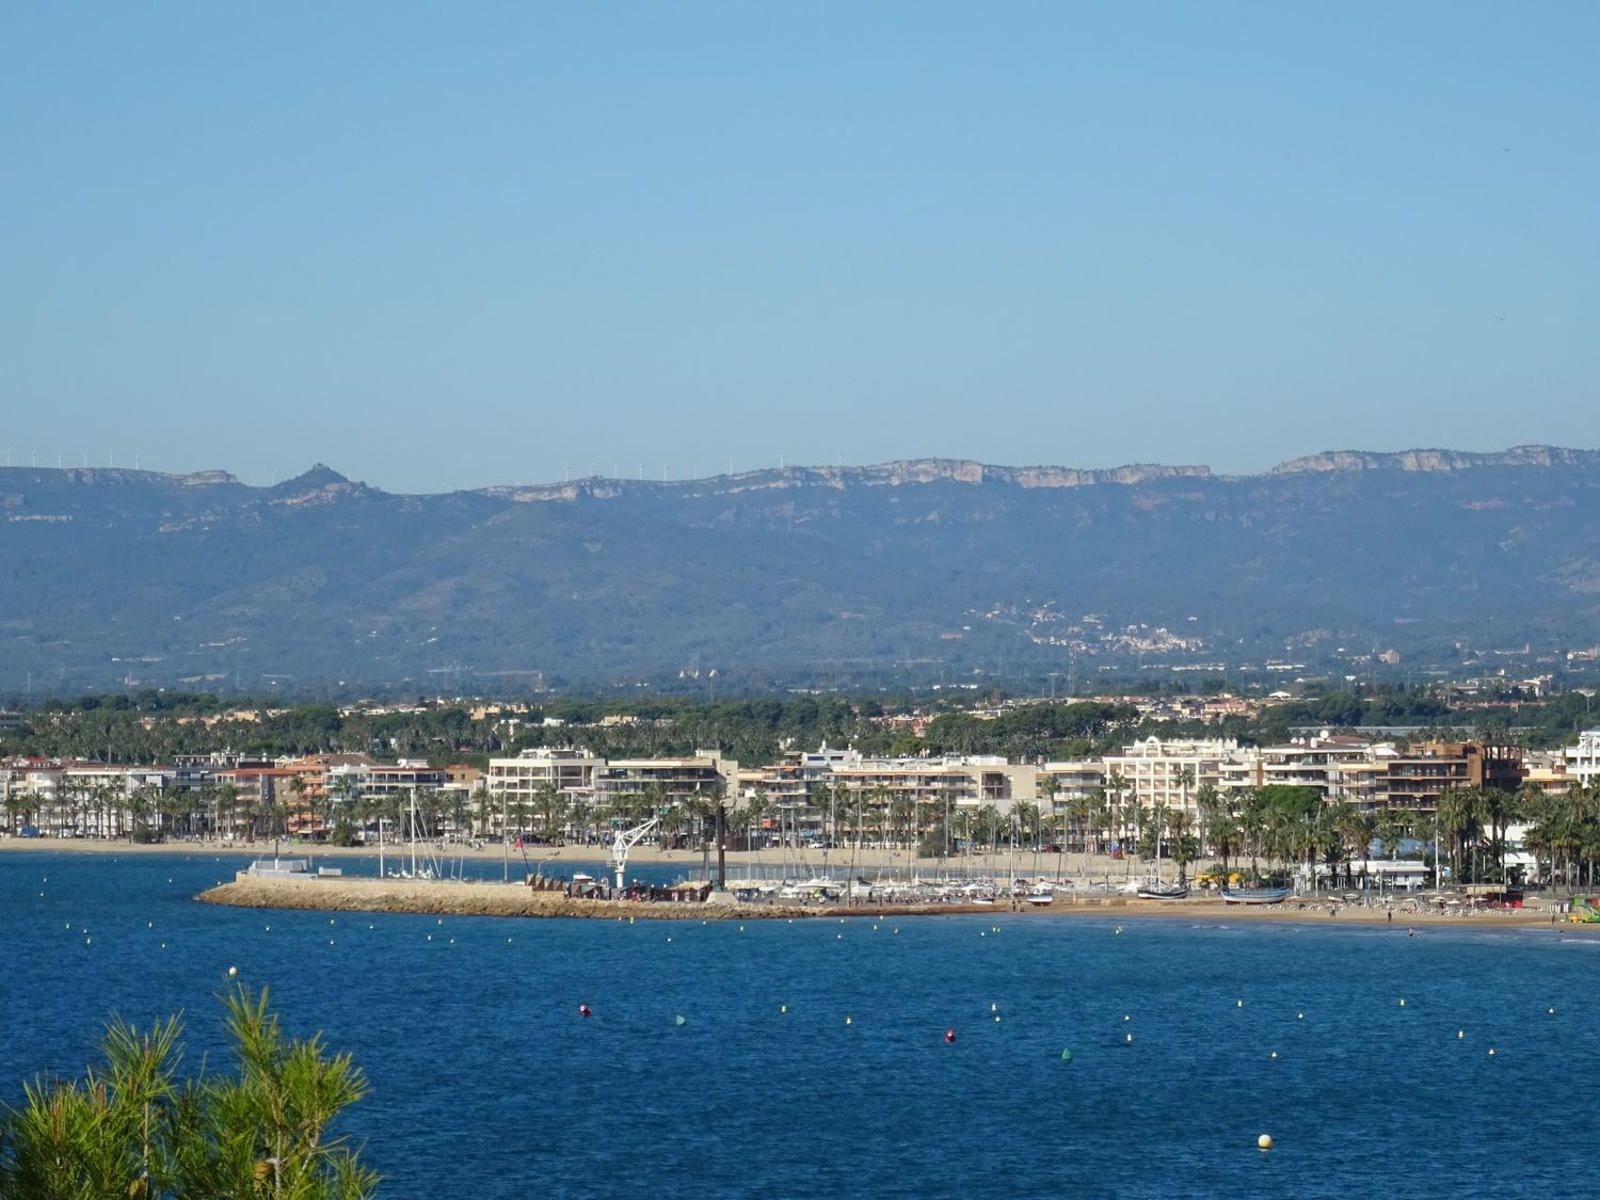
[0, 853, 1600, 1200]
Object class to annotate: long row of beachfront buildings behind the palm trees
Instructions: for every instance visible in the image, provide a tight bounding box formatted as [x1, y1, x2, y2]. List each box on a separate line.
[9, 730, 1600, 837]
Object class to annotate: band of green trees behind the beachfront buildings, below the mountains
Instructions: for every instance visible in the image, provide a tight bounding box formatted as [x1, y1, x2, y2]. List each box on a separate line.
[0, 688, 1597, 766]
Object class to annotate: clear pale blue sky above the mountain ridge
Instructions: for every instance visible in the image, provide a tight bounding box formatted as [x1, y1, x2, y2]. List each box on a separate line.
[0, 0, 1600, 491]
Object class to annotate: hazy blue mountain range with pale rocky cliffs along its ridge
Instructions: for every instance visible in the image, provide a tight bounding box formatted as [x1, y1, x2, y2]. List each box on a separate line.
[0, 446, 1600, 696]
